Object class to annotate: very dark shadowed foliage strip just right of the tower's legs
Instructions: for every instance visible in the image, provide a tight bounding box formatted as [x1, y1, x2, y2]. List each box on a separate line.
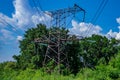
[66, 41, 80, 75]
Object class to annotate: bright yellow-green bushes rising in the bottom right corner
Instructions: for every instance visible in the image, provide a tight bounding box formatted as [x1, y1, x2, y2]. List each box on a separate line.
[76, 53, 120, 80]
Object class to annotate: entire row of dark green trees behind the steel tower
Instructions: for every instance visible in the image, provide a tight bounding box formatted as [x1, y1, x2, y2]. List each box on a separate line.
[13, 24, 118, 74]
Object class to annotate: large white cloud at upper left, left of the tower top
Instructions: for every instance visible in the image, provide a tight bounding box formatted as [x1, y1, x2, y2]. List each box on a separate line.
[0, 0, 51, 30]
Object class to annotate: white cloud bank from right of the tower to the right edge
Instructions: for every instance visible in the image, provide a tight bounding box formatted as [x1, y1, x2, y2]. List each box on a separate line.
[69, 17, 120, 40]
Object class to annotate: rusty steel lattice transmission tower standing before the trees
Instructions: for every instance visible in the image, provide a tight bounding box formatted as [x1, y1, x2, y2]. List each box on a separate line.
[35, 4, 85, 73]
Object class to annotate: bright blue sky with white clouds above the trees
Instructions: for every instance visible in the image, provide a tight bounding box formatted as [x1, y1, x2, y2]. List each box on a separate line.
[0, 0, 120, 62]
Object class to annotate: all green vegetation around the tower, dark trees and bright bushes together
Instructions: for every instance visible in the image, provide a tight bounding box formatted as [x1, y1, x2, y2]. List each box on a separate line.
[0, 24, 120, 80]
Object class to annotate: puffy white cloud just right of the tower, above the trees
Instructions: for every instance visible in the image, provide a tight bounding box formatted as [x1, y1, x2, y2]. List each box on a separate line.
[69, 20, 102, 37]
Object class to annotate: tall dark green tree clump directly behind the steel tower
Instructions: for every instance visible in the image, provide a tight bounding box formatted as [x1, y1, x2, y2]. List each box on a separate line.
[13, 24, 79, 74]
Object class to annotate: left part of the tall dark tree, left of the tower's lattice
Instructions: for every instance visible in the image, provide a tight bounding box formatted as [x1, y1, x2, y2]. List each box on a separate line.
[13, 24, 48, 69]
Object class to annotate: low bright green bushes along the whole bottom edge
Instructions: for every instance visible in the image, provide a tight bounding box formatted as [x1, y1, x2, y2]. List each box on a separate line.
[0, 53, 120, 80]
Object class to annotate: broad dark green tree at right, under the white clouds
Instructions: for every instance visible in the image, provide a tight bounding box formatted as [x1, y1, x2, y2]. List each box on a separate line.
[79, 35, 118, 68]
